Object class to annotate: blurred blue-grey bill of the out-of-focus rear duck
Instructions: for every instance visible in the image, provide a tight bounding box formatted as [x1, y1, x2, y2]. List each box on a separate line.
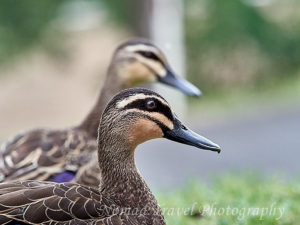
[158, 67, 201, 97]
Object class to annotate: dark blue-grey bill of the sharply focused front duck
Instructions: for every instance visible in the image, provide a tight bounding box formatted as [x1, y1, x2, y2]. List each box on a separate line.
[164, 117, 221, 153]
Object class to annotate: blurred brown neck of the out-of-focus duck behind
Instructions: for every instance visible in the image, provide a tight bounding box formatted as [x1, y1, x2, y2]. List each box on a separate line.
[78, 64, 126, 138]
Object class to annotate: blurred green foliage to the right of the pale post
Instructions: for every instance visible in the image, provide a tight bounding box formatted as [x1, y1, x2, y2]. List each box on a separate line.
[185, 0, 300, 93]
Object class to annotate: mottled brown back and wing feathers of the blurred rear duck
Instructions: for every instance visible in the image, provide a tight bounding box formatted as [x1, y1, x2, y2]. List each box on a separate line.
[0, 129, 97, 182]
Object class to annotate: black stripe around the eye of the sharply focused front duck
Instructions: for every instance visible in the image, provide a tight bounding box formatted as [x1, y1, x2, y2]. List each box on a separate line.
[124, 98, 173, 121]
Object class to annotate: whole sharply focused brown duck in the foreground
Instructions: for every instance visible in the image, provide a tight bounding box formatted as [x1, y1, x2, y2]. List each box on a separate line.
[0, 88, 221, 225]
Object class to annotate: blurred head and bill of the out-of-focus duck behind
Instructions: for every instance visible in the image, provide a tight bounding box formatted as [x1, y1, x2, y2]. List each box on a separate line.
[112, 39, 201, 96]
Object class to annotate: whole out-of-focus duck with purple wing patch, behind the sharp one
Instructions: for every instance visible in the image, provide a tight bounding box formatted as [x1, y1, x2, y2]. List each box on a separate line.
[0, 38, 201, 186]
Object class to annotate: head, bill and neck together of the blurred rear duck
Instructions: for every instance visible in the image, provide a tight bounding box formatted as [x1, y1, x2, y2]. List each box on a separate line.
[79, 39, 201, 138]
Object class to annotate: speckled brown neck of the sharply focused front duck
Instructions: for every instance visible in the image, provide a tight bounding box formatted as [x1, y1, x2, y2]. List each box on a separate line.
[98, 112, 165, 225]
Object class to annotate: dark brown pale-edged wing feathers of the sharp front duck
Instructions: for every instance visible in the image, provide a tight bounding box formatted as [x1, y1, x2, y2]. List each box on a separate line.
[0, 181, 139, 225]
